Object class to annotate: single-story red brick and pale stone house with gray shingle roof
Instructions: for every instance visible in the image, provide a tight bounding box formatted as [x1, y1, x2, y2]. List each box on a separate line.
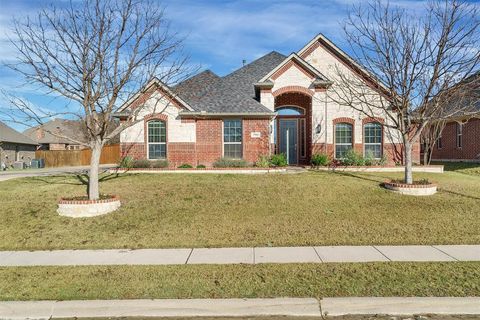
[117, 34, 412, 166]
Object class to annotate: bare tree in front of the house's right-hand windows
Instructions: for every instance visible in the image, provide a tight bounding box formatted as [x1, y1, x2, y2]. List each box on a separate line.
[331, 0, 480, 184]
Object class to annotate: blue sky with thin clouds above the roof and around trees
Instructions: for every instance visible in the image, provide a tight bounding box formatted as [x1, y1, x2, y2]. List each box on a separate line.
[0, 0, 436, 130]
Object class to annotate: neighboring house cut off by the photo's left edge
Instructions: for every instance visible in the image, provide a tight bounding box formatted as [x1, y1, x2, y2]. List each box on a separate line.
[0, 122, 37, 169]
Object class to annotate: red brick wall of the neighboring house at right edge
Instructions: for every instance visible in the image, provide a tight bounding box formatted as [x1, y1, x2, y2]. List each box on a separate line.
[432, 119, 480, 161]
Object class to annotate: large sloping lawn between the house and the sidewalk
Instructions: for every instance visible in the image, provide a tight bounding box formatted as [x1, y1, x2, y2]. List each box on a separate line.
[0, 168, 480, 250]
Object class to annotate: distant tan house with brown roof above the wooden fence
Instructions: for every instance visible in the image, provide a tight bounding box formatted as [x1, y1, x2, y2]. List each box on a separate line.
[23, 119, 87, 150]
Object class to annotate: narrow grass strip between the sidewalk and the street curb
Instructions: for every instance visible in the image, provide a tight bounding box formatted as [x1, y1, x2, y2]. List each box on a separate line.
[0, 262, 480, 300]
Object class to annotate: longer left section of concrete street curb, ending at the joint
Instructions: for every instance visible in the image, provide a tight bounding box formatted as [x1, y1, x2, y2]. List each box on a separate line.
[0, 298, 321, 319]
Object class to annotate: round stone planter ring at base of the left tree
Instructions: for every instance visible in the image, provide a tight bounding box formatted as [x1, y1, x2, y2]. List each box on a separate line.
[57, 196, 120, 218]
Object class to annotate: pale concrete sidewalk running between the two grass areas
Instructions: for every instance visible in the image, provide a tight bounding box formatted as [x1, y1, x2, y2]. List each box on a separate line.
[0, 245, 480, 266]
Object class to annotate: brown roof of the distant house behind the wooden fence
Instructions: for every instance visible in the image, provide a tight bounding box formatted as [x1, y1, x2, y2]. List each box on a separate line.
[23, 119, 88, 144]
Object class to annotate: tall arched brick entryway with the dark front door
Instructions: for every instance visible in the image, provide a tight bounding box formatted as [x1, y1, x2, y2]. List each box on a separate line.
[274, 92, 312, 165]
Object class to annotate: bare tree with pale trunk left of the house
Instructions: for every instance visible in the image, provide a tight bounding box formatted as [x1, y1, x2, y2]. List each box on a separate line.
[2, 0, 186, 200]
